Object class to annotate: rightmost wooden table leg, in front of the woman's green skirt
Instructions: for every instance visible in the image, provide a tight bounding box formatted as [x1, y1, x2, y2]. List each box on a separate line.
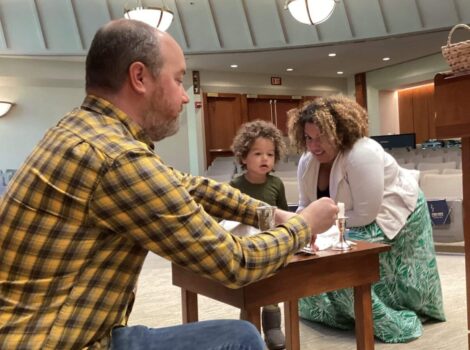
[354, 284, 374, 350]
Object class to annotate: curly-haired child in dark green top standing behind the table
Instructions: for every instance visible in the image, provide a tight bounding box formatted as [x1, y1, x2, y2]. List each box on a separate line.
[230, 120, 288, 350]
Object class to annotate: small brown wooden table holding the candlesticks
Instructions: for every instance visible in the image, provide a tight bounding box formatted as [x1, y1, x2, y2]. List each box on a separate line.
[172, 241, 390, 350]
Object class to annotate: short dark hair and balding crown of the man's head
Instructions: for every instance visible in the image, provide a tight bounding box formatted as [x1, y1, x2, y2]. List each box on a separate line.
[86, 19, 165, 93]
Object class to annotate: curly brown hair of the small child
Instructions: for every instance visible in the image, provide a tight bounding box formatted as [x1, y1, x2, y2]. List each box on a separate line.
[232, 120, 286, 170]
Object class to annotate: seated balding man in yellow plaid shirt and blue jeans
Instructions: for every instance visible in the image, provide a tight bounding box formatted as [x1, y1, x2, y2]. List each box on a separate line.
[0, 19, 337, 350]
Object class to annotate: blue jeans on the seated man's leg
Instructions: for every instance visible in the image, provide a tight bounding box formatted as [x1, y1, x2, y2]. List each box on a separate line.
[111, 320, 265, 350]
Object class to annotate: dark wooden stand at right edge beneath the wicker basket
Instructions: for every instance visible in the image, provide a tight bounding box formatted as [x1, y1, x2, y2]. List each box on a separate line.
[434, 73, 470, 346]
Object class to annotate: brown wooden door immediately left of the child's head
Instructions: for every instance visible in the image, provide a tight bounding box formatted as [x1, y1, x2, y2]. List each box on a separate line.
[203, 93, 246, 166]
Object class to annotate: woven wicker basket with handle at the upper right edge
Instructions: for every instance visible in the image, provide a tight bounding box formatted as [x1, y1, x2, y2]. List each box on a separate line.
[441, 24, 470, 72]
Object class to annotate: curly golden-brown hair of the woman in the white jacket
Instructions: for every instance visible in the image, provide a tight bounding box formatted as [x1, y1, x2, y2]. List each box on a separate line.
[287, 95, 368, 153]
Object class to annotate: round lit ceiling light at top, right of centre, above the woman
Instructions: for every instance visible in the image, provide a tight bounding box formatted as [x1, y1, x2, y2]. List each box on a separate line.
[284, 0, 336, 25]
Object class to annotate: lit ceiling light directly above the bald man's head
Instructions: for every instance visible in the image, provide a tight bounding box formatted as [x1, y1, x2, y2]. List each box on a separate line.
[124, 0, 173, 32]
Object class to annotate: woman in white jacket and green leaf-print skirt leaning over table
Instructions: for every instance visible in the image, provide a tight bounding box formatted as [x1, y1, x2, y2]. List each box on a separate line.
[289, 95, 445, 343]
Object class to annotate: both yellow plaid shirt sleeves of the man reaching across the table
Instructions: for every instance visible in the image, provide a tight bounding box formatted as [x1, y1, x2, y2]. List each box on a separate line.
[90, 153, 311, 287]
